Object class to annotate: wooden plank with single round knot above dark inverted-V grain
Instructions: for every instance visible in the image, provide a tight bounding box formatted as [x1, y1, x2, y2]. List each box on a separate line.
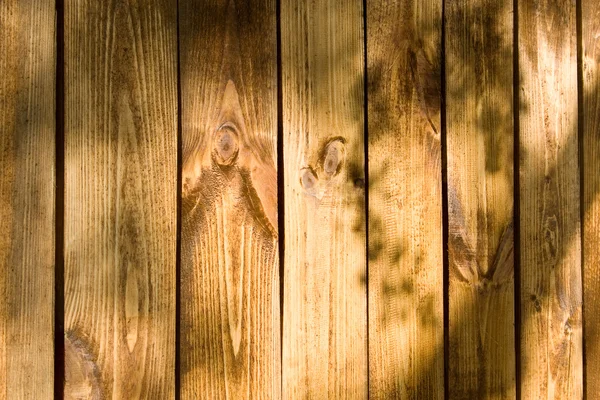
[179, 0, 281, 399]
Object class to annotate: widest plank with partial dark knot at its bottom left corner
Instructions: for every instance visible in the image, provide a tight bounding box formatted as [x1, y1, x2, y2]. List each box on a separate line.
[64, 0, 177, 399]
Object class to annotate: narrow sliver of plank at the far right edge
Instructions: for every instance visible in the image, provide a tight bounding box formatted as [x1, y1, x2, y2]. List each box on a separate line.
[580, 0, 600, 399]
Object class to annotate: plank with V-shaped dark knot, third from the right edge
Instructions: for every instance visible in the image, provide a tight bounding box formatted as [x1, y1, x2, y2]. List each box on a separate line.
[445, 0, 516, 399]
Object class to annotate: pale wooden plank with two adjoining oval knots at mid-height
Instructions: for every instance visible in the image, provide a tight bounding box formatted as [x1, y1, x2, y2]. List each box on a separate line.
[281, 0, 368, 399]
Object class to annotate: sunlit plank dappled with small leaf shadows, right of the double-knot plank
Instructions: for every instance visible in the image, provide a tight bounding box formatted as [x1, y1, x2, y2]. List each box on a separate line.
[367, 0, 444, 399]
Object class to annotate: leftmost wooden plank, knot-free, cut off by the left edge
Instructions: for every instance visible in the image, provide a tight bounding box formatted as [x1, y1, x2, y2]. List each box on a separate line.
[0, 0, 56, 400]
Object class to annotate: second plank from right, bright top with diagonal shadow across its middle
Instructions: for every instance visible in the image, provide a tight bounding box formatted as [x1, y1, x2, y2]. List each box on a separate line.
[518, 0, 583, 399]
